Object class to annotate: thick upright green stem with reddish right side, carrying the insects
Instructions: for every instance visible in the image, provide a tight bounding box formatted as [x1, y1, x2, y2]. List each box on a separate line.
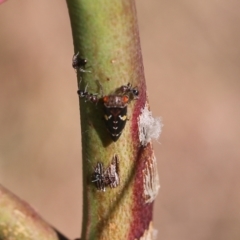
[67, 0, 158, 240]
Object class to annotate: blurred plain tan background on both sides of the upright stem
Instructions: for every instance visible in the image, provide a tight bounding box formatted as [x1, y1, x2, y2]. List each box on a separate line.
[0, 0, 240, 240]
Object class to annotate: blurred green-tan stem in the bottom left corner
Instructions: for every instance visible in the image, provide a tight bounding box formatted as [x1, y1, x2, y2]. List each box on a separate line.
[0, 185, 67, 240]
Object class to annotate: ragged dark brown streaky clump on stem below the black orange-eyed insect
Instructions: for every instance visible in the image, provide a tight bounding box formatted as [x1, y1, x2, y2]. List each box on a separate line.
[92, 154, 120, 192]
